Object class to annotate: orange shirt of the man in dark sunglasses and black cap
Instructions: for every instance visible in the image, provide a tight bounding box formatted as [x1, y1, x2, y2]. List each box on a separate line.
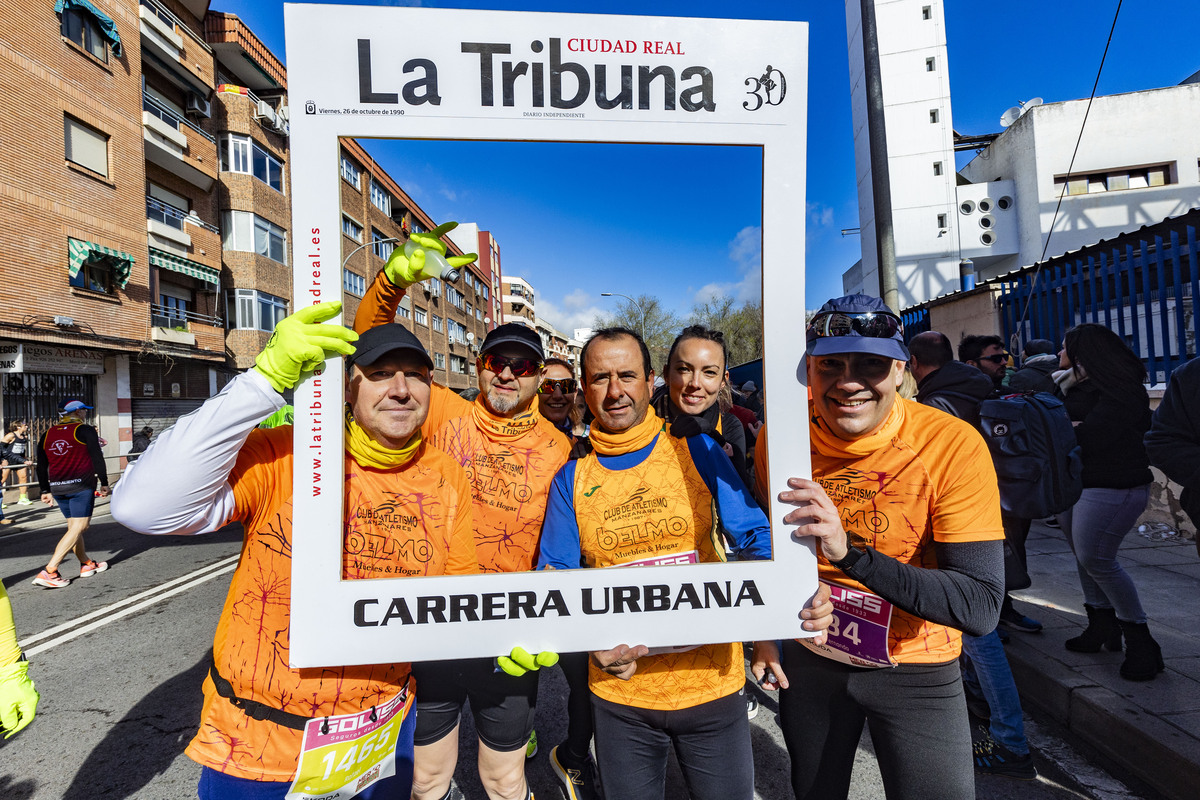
[428, 398, 570, 572]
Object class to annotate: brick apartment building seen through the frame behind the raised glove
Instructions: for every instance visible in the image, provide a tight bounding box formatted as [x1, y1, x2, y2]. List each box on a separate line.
[338, 139, 492, 391]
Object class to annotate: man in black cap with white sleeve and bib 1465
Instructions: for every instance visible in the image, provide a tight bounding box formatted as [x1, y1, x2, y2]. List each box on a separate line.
[113, 302, 478, 800]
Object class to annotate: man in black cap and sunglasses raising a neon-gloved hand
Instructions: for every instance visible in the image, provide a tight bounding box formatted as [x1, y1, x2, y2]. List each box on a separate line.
[354, 222, 570, 800]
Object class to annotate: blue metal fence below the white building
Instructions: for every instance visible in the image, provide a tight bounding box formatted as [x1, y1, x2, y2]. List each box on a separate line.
[988, 209, 1200, 384]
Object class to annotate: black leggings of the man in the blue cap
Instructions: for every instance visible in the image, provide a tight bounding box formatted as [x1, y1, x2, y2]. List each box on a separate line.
[779, 640, 974, 800]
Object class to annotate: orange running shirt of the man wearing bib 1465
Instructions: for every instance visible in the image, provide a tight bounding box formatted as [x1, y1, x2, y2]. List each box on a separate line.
[186, 426, 478, 781]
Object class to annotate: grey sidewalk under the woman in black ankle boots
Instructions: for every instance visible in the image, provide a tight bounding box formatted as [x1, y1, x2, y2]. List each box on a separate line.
[1006, 522, 1200, 800]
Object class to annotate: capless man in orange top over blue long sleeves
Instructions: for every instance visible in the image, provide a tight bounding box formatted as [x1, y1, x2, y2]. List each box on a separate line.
[539, 327, 829, 800]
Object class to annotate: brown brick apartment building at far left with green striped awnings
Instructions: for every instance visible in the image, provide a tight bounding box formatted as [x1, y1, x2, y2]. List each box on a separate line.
[0, 0, 226, 467]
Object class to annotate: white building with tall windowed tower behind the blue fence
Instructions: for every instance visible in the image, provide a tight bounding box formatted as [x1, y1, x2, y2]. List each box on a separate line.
[842, 0, 1200, 308]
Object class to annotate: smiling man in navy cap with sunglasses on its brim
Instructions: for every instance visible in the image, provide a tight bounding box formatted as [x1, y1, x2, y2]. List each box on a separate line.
[755, 295, 1004, 800]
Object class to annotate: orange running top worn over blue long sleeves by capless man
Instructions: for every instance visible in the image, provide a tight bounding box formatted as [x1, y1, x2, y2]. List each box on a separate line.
[574, 434, 745, 710]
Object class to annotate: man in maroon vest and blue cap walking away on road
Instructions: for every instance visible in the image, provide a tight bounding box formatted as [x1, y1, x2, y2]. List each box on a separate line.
[34, 398, 108, 589]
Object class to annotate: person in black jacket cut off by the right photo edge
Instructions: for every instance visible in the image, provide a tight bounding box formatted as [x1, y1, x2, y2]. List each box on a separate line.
[1145, 359, 1200, 549]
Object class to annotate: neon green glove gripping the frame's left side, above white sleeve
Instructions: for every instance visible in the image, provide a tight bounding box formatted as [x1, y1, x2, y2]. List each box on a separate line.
[254, 300, 359, 393]
